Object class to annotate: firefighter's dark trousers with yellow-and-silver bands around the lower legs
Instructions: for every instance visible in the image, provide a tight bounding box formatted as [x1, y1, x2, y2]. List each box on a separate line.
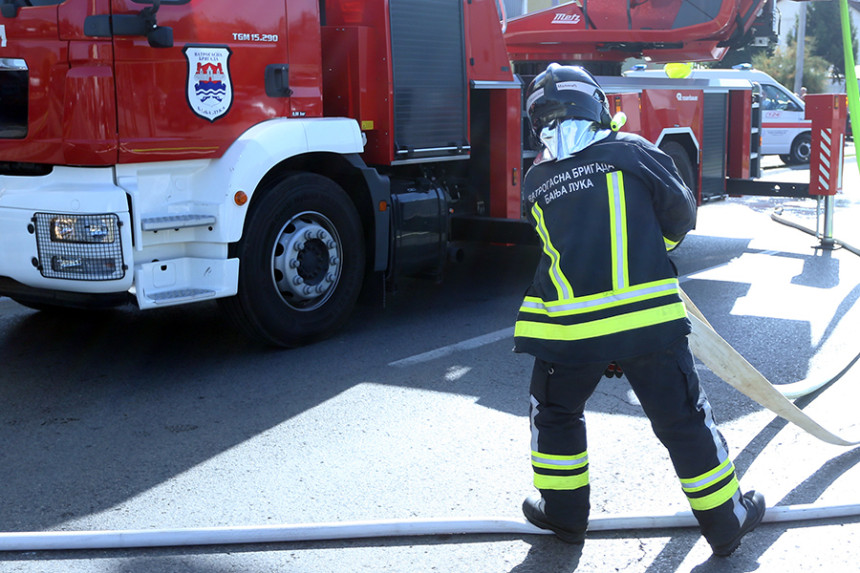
[530, 337, 746, 544]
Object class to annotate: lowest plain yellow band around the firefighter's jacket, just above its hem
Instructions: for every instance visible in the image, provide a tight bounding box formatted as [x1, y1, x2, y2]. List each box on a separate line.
[514, 302, 687, 340]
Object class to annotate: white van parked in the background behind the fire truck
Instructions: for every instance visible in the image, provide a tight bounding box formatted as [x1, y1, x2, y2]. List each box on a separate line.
[624, 69, 812, 163]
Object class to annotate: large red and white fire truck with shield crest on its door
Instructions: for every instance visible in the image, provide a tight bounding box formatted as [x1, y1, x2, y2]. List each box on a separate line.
[0, 0, 772, 346]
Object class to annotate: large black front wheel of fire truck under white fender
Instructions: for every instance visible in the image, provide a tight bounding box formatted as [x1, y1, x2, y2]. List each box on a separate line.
[220, 173, 364, 347]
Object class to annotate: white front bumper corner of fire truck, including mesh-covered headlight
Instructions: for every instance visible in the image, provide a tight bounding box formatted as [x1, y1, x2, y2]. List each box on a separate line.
[0, 167, 133, 294]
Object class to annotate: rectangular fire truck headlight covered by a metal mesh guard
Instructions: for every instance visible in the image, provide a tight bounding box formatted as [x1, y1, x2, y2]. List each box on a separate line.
[33, 213, 127, 281]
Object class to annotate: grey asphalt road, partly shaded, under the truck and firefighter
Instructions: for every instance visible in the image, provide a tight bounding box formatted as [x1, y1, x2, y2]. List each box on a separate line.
[0, 150, 860, 573]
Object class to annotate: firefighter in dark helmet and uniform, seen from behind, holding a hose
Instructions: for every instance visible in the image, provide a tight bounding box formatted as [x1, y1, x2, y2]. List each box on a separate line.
[515, 64, 765, 556]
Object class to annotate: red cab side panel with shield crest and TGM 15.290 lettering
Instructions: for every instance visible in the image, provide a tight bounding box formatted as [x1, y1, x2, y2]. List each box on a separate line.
[112, 0, 322, 163]
